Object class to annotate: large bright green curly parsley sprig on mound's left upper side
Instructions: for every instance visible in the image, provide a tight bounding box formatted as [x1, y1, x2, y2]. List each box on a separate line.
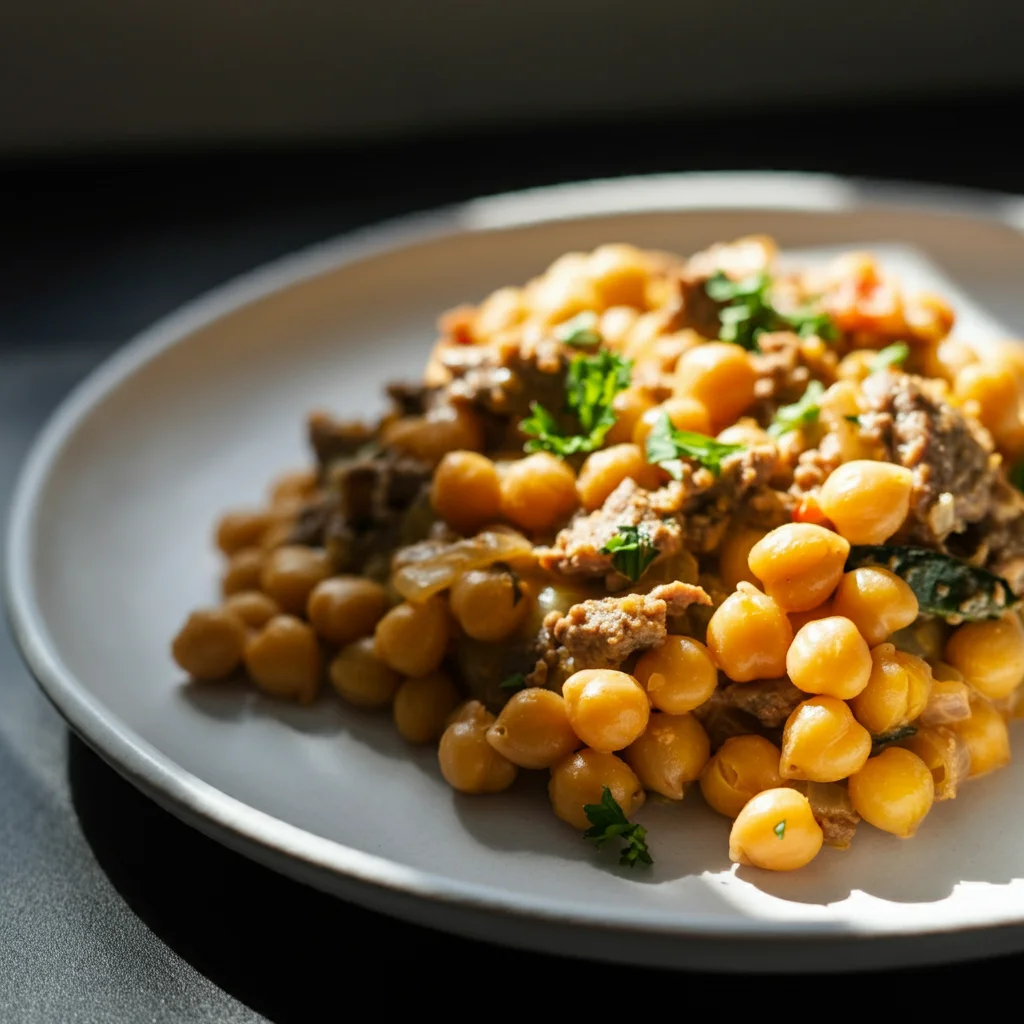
[519, 349, 633, 459]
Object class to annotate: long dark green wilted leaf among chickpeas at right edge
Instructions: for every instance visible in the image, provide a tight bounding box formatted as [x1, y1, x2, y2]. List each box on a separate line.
[846, 544, 1017, 623]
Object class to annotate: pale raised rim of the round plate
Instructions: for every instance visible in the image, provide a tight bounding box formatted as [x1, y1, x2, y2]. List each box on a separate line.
[12, 171, 1024, 941]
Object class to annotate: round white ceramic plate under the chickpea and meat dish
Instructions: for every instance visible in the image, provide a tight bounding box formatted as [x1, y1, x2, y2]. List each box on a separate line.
[7, 175, 1024, 970]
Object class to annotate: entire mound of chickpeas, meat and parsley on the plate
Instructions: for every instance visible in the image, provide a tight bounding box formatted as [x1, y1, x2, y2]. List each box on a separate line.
[173, 238, 1024, 870]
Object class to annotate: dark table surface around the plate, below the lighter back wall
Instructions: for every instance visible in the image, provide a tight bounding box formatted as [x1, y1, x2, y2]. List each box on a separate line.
[6, 95, 1024, 1024]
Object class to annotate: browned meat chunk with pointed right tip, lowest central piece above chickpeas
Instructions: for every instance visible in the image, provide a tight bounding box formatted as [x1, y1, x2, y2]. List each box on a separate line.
[545, 583, 711, 670]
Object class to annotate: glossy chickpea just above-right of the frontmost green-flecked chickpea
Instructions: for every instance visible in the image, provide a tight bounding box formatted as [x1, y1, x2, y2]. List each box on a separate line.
[779, 696, 871, 782]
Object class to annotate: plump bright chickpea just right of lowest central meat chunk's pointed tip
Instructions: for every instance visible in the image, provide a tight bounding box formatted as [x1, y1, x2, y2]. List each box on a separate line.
[708, 583, 793, 683]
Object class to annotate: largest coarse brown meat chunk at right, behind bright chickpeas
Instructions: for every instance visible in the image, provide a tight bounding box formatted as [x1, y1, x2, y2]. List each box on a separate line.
[862, 373, 1001, 547]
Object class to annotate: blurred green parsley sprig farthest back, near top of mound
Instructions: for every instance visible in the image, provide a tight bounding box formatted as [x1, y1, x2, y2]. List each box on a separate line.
[705, 270, 839, 352]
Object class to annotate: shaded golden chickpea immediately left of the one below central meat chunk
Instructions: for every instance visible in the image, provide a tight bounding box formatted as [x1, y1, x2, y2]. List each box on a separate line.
[487, 686, 580, 768]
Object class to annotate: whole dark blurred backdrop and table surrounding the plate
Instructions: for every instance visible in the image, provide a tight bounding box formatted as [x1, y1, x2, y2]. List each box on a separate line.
[0, 0, 1024, 1024]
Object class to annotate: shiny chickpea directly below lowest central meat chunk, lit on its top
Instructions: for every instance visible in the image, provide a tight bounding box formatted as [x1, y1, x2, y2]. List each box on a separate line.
[562, 669, 650, 752]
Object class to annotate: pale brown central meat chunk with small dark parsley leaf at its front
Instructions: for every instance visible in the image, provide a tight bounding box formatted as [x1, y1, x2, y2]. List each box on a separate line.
[540, 474, 688, 589]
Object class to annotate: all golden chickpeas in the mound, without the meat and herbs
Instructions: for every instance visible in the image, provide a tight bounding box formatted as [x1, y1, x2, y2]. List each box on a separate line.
[173, 240, 1024, 870]
